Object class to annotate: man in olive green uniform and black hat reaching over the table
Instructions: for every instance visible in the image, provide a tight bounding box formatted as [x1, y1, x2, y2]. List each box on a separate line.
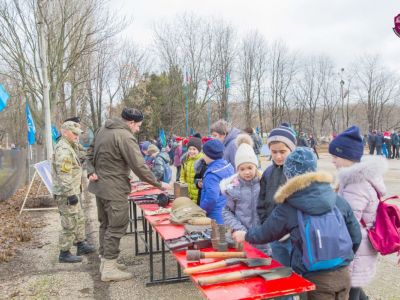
[87, 108, 169, 281]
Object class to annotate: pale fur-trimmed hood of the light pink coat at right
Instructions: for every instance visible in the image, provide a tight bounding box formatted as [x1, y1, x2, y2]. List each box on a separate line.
[338, 155, 388, 195]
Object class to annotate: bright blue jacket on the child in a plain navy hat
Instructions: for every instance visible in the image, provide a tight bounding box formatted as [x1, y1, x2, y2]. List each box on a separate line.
[200, 158, 234, 224]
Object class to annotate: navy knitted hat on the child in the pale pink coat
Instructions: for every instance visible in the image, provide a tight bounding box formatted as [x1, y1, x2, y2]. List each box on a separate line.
[329, 126, 364, 161]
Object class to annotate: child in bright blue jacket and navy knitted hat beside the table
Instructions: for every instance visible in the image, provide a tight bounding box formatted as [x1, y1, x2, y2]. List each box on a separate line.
[200, 140, 234, 224]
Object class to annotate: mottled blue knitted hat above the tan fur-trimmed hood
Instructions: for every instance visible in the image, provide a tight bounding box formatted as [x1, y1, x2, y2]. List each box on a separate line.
[283, 147, 317, 179]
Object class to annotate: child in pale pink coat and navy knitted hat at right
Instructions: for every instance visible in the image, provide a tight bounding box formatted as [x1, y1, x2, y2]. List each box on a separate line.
[329, 126, 388, 300]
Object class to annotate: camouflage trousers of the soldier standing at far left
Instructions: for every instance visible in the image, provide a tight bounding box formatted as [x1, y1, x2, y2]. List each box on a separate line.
[56, 196, 85, 251]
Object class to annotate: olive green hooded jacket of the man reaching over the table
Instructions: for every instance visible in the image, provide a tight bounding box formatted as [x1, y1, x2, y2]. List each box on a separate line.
[86, 118, 161, 200]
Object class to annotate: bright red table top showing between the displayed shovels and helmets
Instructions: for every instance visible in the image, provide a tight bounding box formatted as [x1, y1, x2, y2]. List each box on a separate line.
[130, 182, 315, 300]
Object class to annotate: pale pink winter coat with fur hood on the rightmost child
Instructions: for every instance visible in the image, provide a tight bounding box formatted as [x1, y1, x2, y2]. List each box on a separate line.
[338, 156, 388, 287]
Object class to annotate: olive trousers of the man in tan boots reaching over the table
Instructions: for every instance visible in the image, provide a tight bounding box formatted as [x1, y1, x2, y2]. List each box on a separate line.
[96, 196, 129, 259]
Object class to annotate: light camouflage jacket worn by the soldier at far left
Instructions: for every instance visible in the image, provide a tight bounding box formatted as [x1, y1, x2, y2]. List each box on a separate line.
[52, 137, 82, 196]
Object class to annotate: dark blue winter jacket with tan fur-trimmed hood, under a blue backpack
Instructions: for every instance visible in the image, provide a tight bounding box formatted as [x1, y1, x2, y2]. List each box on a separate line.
[246, 172, 361, 274]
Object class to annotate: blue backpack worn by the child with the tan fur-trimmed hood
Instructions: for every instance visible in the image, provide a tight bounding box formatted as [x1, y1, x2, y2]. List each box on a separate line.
[297, 206, 353, 271]
